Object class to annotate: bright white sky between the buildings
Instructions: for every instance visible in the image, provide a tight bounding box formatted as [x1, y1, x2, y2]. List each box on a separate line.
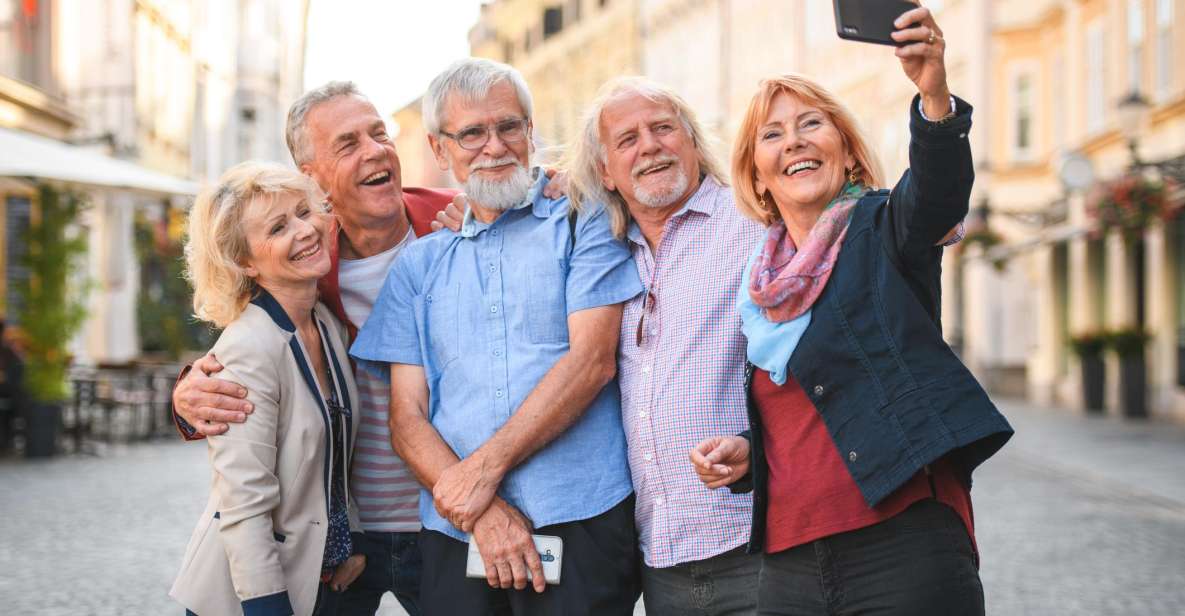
[305, 0, 482, 117]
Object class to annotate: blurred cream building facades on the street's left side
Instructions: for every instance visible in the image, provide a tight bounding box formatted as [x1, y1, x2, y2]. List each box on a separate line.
[0, 0, 308, 364]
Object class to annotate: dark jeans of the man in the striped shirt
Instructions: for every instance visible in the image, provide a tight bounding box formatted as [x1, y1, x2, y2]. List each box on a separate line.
[335, 532, 422, 616]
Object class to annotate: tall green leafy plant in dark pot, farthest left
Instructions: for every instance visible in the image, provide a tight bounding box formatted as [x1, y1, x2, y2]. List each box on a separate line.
[17, 184, 87, 457]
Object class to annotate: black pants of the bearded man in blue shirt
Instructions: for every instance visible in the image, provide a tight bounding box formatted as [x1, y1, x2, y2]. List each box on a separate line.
[419, 494, 640, 616]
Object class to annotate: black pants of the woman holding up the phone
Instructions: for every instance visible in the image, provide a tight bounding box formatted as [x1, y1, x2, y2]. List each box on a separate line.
[757, 499, 984, 616]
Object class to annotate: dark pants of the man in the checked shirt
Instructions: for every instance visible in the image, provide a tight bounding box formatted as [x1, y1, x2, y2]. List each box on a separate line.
[642, 546, 761, 616]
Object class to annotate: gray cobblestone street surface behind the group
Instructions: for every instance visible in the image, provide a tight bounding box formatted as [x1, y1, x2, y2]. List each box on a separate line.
[0, 404, 1185, 616]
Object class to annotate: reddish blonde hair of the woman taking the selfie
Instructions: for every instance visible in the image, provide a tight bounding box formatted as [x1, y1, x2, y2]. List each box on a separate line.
[732, 75, 883, 226]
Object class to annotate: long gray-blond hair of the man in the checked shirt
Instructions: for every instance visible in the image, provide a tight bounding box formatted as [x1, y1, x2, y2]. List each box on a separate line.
[561, 77, 729, 238]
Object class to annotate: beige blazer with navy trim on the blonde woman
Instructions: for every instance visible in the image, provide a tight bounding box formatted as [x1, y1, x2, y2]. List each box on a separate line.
[169, 293, 358, 616]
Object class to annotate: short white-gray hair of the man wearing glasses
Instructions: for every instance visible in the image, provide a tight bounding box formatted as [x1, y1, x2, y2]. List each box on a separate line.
[422, 58, 534, 135]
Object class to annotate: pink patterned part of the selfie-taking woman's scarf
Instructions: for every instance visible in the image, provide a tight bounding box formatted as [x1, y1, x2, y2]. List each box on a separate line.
[749, 182, 869, 322]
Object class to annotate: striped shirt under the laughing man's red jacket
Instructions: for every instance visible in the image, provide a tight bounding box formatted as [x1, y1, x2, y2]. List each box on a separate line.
[338, 230, 419, 532]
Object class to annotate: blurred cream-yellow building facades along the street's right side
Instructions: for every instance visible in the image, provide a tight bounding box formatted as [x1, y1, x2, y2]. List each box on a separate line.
[470, 0, 1185, 418]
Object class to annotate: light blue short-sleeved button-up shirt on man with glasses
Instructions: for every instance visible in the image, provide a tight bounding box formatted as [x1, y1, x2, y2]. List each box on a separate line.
[351, 169, 641, 540]
